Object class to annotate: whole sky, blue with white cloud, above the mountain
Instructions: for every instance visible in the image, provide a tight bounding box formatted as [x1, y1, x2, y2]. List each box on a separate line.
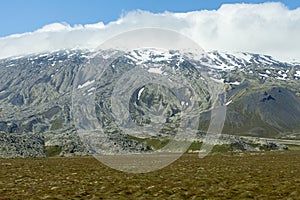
[0, 0, 300, 62]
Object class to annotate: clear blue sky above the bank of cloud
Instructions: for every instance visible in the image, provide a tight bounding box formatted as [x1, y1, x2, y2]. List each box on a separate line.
[0, 0, 300, 37]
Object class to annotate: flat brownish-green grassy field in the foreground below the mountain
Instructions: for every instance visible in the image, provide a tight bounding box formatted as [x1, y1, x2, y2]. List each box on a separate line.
[0, 151, 300, 199]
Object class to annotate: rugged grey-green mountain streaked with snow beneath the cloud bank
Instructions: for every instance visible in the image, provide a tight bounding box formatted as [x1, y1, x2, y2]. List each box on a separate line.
[0, 50, 300, 157]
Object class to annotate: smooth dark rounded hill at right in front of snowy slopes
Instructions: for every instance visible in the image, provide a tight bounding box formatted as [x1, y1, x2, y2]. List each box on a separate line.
[224, 86, 300, 138]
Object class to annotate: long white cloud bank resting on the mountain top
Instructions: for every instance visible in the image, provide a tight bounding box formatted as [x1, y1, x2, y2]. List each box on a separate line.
[0, 3, 300, 61]
